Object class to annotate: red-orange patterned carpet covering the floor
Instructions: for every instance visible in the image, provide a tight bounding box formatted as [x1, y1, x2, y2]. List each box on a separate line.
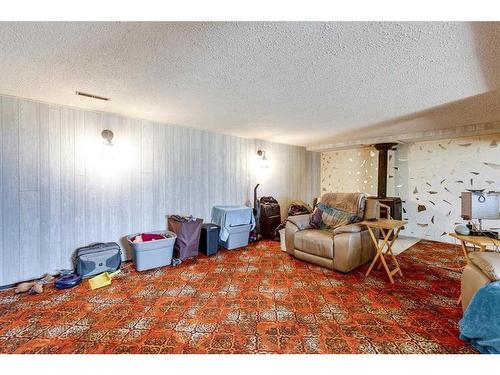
[0, 242, 475, 353]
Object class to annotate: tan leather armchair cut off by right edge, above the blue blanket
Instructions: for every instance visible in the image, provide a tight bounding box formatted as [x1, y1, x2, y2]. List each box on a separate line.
[461, 251, 500, 311]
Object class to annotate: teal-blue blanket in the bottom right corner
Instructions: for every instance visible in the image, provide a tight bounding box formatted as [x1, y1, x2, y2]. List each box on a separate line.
[459, 281, 500, 354]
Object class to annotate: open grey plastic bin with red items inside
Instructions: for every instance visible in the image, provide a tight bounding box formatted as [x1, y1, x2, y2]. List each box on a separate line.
[127, 230, 177, 271]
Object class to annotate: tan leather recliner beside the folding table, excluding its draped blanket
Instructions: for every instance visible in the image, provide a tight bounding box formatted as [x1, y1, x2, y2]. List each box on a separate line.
[285, 197, 380, 272]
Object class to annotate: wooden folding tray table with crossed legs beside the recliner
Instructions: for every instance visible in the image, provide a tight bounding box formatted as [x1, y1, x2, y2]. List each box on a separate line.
[360, 219, 408, 284]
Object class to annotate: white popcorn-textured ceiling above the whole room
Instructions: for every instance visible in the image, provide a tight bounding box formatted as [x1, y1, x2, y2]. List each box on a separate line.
[0, 22, 500, 145]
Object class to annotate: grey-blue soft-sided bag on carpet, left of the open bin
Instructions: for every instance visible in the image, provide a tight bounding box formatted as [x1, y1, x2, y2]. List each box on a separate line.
[75, 242, 122, 278]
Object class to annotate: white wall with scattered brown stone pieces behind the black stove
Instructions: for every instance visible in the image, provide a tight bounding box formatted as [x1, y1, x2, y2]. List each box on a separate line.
[321, 134, 500, 242]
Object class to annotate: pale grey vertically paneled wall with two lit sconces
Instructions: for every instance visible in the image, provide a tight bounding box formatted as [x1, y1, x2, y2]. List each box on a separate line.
[0, 96, 320, 285]
